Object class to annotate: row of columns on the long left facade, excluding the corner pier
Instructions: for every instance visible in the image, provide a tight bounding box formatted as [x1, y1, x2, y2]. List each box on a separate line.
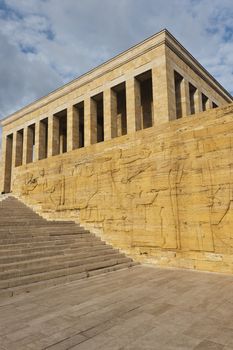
[12, 69, 159, 167]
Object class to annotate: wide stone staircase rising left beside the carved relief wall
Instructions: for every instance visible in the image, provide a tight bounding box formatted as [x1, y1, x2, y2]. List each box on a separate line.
[0, 196, 135, 298]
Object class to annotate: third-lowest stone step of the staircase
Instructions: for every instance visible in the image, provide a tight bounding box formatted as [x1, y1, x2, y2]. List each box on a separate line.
[0, 250, 125, 281]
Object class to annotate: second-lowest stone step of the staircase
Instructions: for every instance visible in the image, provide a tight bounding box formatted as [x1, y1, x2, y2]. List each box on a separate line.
[0, 257, 131, 289]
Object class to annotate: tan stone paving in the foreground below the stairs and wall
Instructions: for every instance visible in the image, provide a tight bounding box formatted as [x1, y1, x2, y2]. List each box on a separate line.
[0, 266, 233, 350]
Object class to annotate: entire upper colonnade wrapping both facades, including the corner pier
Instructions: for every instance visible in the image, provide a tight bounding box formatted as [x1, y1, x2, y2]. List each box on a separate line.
[3, 67, 217, 190]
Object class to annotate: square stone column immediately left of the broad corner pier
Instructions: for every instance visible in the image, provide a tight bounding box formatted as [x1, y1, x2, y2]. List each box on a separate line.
[126, 77, 142, 134]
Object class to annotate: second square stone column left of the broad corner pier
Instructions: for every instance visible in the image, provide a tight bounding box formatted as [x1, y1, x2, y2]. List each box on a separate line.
[104, 88, 117, 141]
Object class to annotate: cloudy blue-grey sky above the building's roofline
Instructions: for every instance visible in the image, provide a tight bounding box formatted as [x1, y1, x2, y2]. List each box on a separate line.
[0, 0, 233, 119]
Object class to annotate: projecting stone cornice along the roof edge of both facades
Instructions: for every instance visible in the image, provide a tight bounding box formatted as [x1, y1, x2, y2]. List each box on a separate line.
[0, 29, 233, 126]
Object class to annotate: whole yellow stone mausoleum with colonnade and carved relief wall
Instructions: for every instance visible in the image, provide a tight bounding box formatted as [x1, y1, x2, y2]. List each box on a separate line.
[1, 30, 233, 272]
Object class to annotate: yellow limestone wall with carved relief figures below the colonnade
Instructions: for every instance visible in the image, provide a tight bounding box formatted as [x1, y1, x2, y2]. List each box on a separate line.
[13, 104, 233, 273]
